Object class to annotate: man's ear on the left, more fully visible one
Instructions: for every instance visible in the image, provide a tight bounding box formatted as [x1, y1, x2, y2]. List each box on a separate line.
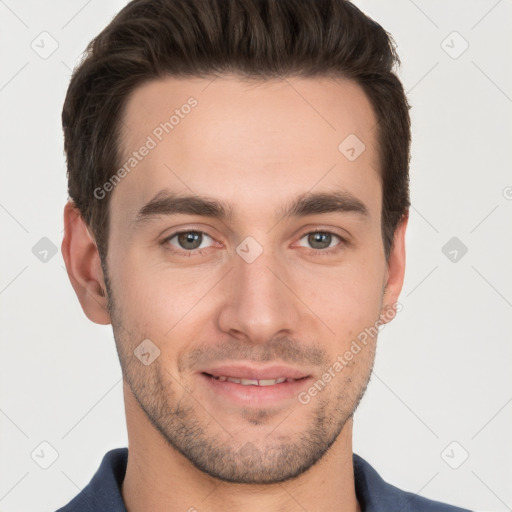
[61, 201, 110, 324]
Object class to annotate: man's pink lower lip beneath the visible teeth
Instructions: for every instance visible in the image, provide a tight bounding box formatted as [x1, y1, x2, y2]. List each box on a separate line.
[199, 373, 311, 407]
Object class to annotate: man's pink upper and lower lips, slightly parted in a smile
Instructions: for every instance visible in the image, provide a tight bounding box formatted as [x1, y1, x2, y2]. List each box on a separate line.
[198, 365, 313, 408]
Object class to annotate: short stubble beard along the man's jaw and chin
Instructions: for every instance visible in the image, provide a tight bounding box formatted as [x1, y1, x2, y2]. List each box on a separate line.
[105, 273, 374, 484]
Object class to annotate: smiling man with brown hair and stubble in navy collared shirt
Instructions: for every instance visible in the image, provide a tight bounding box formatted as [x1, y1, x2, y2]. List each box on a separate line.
[57, 0, 472, 512]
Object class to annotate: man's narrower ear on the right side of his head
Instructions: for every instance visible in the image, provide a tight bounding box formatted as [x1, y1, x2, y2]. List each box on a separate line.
[381, 212, 409, 324]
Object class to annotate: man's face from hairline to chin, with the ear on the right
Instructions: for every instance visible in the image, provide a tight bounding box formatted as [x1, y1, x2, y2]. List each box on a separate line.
[65, 72, 405, 483]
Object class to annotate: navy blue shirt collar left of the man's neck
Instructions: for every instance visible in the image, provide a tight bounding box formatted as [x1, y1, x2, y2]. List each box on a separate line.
[57, 448, 128, 512]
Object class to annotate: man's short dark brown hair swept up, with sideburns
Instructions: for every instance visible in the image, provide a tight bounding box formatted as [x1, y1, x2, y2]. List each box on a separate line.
[62, 0, 410, 261]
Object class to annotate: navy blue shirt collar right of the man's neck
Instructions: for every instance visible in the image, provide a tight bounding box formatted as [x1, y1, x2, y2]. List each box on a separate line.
[353, 453, 470, 512]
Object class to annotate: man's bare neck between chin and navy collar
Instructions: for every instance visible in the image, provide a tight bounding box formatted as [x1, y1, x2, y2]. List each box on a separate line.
[121, 384, 361, 512]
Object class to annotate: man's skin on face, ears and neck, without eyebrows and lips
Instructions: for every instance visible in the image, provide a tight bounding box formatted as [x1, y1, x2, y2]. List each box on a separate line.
[62, 75, 407, 512]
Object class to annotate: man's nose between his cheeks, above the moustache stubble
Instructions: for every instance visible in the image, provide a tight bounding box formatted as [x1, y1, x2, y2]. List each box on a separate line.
[218, 244, 304, 344]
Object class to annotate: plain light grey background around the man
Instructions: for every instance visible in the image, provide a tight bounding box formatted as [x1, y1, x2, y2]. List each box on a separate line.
[0, 0, 512, 512]
